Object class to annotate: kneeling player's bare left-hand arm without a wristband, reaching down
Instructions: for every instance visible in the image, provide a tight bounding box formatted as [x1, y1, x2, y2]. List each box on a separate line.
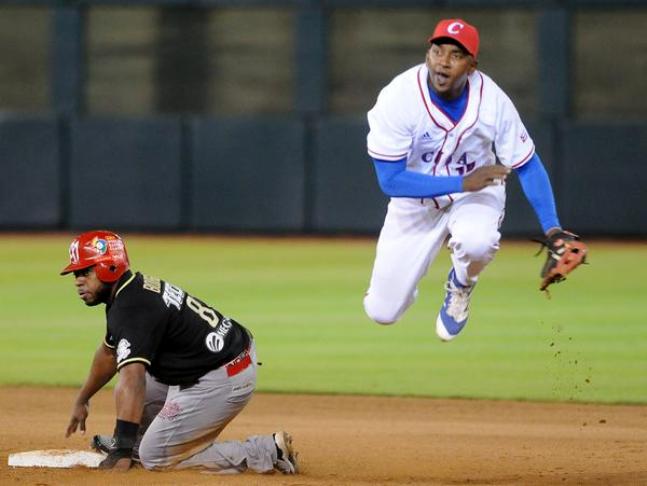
[65, 343, 117, 437]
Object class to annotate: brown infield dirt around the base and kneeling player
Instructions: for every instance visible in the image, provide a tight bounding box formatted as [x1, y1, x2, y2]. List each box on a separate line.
[0, 387, 647, 486]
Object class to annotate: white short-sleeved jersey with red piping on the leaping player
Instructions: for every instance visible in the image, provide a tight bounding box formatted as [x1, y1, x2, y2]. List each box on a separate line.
[367, 64, 535, 208]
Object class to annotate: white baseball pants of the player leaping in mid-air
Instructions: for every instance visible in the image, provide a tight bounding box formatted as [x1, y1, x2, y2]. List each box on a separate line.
[364, 186, 505, 324]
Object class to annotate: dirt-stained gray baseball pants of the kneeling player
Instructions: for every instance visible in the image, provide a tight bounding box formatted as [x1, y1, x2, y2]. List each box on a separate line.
[136, 342, 277, 473]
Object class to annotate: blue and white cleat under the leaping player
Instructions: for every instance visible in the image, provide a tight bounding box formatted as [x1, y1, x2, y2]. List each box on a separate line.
[436, 268, 474, 341]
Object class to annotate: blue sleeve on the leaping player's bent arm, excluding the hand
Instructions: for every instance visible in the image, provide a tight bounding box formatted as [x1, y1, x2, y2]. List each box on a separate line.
[373, 159, 463, 197]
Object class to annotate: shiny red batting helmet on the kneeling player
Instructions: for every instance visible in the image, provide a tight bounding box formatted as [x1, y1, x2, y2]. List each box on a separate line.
[61, 231, 129, 283]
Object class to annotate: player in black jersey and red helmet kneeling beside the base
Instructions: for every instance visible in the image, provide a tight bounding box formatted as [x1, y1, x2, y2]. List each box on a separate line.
[61, 231, 298, 474]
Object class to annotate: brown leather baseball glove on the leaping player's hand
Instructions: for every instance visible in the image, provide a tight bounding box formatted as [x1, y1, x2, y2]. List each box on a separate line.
[539, 230, 588, 293]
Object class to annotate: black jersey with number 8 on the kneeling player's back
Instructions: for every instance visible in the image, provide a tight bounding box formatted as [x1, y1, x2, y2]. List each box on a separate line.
[105, 272, 250, 385]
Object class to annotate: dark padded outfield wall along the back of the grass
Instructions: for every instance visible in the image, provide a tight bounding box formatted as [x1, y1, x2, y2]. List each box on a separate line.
[0, 117, 647, 235]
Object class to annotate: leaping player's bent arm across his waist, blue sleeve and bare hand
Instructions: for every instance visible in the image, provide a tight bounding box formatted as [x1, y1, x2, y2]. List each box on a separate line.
[373, 159, 510, 197]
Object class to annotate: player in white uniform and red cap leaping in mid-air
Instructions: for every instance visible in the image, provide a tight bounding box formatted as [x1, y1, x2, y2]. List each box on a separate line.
[364, 19, 561, 341]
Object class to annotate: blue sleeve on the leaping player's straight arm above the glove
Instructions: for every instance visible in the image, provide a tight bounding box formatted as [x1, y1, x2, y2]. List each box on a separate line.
[515, 152, 560, 233]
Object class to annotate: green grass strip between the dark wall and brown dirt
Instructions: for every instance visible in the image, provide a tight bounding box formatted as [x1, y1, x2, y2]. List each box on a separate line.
[0, 234, 647, 403]
